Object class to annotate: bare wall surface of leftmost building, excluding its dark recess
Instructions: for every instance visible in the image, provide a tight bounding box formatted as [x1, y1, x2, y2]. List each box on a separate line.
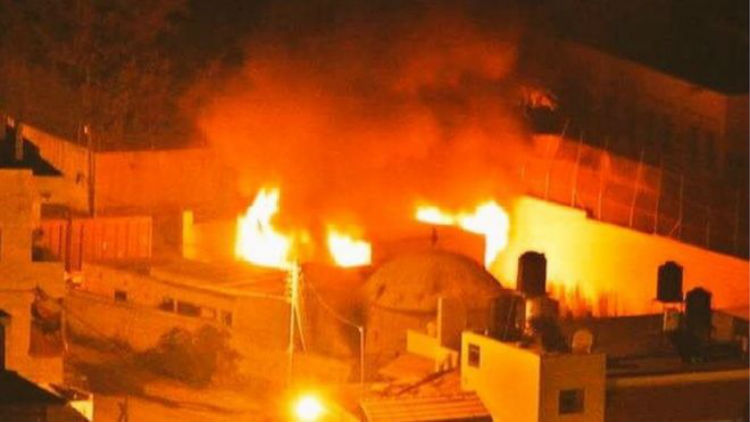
[0, 170, 65, 383]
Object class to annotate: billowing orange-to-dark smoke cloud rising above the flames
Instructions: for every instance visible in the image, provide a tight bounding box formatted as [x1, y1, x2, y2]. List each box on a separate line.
[199, 2, 525, 241]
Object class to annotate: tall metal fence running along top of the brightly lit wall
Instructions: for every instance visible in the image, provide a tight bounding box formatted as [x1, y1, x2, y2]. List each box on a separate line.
[521, 137, 748, 258]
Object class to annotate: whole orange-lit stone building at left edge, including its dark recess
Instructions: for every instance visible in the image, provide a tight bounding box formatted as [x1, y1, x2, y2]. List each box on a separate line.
[0, 169, 65, 383]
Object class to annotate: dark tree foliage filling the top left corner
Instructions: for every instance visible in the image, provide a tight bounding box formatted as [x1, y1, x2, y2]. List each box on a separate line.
[0, 0, 185, 148]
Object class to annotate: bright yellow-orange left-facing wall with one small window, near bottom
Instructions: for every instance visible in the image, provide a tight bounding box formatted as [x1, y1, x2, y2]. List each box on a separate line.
[461, 331, 541, 422]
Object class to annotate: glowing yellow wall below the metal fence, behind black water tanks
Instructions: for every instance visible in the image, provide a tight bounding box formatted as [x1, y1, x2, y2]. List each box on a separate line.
[492, 197, 749, 315]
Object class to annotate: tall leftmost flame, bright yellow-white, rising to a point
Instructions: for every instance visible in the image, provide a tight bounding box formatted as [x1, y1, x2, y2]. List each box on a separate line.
[235, 188, 292, 269]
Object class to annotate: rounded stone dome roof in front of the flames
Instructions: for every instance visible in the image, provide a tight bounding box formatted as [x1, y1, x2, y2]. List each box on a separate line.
[365, 250, 503, 312]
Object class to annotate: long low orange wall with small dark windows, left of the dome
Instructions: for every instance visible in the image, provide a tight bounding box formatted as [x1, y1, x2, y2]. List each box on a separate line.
[67, 264, 289, 382]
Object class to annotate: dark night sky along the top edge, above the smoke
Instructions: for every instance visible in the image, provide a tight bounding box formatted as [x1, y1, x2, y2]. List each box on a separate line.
[175, 0, 748, 93]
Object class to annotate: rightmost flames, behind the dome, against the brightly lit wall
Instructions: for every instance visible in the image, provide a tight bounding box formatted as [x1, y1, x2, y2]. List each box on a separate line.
[416, 201, 510, 268]
